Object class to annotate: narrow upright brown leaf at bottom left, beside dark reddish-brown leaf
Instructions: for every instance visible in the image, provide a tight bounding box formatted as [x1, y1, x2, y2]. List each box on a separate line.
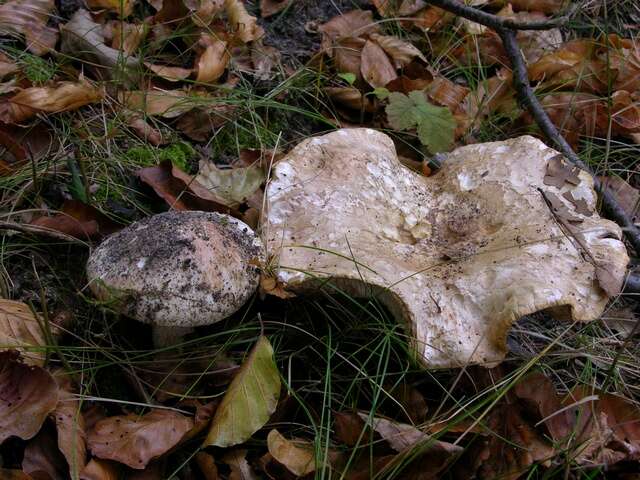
[52, 370, 87, 478]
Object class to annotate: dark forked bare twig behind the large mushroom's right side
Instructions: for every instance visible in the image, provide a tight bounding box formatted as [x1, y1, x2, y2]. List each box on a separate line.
[429, 0, 640, 291]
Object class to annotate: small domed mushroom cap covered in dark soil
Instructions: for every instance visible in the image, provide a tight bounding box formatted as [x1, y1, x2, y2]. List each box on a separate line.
[87, 211, 263, 327]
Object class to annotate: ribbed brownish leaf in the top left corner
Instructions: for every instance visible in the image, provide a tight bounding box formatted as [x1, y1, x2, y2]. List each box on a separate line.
[0, 0, 58, 55]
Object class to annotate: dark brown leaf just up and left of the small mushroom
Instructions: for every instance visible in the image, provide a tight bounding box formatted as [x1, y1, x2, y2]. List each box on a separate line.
[31, 200, 119, 240]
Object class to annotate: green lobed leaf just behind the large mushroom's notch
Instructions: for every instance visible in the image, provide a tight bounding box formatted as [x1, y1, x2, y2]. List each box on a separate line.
[386, 90, 456, 153]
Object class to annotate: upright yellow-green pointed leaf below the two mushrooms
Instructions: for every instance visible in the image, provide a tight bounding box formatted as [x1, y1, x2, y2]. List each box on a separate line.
[204, 336, 280, 447]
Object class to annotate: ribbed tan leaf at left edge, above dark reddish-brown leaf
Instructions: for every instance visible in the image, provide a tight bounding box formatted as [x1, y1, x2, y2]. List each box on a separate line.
[0, 299, 46, 367]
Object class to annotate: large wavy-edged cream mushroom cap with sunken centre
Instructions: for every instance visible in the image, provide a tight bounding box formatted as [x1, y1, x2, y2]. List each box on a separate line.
[263, 129, 628, 367]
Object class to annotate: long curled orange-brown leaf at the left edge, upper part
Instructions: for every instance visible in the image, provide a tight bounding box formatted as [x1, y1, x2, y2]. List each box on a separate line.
[0, 81, 103, 123]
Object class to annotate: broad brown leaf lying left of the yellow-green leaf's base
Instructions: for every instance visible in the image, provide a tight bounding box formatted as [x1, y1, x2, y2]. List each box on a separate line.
[87, 409, 193, 470]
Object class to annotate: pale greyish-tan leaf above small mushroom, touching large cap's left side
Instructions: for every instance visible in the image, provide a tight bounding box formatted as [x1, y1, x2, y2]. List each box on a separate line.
[192, 161, 265, 207]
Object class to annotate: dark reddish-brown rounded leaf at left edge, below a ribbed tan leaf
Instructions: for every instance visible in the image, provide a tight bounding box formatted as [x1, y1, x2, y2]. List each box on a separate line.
[0, 350, 58, 443]
